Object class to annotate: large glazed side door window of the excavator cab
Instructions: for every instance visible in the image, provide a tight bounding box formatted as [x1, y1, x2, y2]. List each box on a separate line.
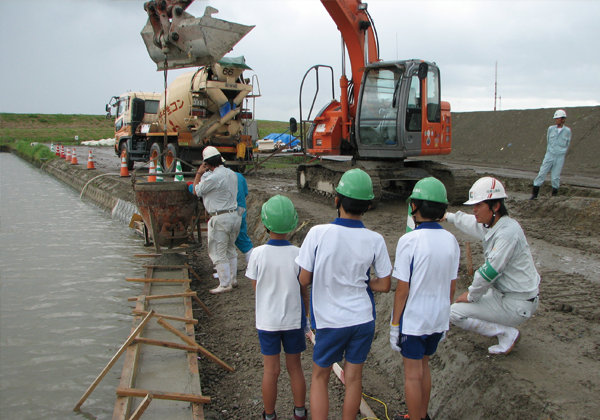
[358, 67, 402, 146]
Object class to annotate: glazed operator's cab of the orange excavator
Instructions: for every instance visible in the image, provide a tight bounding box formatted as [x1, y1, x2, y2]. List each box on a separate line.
[355, 60, 450, 159]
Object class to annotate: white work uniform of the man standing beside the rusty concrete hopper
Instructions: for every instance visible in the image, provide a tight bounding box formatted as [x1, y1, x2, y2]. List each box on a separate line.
[195, 165, 242, 265]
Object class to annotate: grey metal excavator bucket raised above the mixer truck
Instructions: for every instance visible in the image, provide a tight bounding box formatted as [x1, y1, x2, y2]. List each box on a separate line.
[141, 6, 254, 71]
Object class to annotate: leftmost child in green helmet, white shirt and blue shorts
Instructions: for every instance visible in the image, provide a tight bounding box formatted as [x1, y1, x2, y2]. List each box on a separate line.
[246, 195, 310, 420]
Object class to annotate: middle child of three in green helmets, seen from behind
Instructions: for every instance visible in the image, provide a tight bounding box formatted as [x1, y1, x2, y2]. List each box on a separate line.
[296, 169, 392, 420]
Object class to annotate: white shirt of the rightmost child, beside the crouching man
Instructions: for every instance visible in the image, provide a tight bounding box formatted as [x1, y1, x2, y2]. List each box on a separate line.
[392, 222, 460, 336]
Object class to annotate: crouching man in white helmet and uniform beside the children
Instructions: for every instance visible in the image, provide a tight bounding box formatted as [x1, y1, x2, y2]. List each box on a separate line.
[445, 177, 540, 355]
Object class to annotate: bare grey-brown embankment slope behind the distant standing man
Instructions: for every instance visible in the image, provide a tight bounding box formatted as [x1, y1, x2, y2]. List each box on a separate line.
[434, 106, 600, 175]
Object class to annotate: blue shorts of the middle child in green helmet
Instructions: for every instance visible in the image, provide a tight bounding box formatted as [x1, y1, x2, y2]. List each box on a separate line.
[313, 321, 375, 368]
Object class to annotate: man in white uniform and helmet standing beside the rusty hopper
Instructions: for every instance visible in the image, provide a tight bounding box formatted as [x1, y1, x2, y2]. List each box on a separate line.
[194, 146, 242, 294]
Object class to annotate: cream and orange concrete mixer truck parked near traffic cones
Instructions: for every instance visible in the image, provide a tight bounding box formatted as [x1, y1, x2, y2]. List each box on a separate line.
[106, 57, 259, 172]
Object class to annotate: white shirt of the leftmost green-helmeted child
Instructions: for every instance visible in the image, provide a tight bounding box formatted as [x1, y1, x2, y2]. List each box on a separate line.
[246, 239, 306, 331]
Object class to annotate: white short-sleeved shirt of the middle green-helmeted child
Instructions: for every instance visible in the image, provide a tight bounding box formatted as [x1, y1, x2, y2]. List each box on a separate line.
[296, 218, 392, 329]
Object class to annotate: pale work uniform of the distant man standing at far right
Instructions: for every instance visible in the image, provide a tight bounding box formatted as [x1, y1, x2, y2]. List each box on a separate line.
[533, 125, 571, 189]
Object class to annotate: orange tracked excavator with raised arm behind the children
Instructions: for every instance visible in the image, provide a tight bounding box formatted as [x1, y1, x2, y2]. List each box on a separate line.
[144, 0, 470, 206]
